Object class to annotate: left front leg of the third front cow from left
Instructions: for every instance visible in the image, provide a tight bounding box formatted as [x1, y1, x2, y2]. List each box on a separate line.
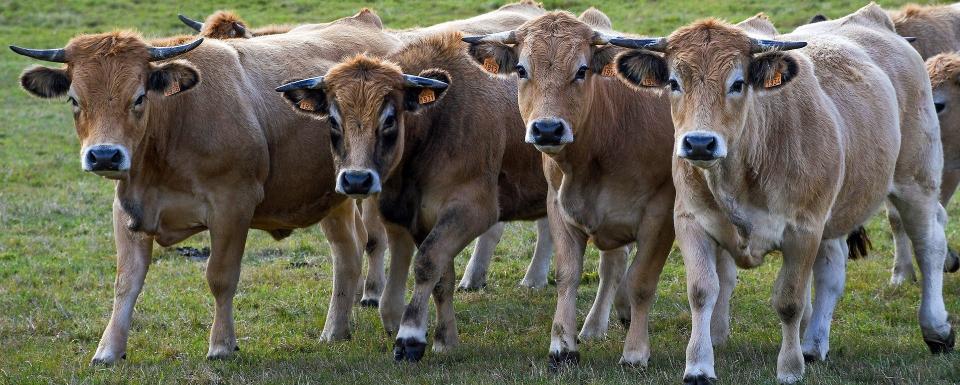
[547, 189, 587, 370]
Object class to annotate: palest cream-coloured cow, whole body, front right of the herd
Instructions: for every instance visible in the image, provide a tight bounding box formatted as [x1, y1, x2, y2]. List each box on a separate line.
[611, 4, 955, 384]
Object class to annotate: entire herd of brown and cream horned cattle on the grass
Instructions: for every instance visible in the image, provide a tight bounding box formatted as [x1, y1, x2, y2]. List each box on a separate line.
[11, 1, 960, 384]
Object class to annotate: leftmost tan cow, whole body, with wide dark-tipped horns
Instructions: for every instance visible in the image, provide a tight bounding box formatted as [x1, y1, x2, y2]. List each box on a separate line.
[11, 10, 398, 364]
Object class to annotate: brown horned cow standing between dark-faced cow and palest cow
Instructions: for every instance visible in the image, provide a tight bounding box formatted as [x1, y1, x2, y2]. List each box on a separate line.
[465, 8, 736, 369]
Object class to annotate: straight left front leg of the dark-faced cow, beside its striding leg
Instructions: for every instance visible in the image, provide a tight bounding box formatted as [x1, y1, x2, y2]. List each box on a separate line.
[380, 223, 417, 338]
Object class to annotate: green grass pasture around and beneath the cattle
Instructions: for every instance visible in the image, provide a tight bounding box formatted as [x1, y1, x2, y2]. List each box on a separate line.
[0, 0, 960, 384]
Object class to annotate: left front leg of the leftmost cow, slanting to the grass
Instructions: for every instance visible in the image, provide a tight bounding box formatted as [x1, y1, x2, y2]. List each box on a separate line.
[91, 200, 153, 365]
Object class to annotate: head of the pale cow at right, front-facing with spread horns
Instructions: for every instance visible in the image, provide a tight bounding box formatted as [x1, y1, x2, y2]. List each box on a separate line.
[610, 19, 806, 168]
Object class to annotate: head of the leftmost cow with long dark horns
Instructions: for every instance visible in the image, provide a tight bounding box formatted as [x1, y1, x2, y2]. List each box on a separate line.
[10, 32, 203, 179]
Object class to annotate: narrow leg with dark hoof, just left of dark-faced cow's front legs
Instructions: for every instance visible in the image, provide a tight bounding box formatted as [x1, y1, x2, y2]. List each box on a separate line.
[360, 199, 387, 307]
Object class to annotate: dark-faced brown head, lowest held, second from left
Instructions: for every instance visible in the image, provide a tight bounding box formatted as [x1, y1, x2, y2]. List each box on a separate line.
[277, 55, 450, 199]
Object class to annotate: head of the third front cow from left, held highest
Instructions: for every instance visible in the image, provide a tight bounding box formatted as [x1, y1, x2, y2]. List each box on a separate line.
[464, 9, 622, 155]
